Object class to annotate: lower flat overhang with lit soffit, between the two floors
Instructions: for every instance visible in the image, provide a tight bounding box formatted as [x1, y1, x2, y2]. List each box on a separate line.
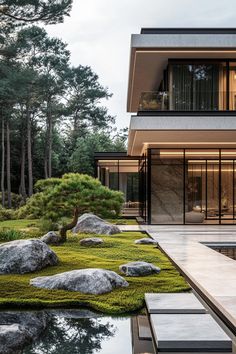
[128, 115, 236, 156]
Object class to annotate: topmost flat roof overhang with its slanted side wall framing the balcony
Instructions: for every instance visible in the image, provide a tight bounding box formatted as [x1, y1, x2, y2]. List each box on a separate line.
[127, 29, 236, 112]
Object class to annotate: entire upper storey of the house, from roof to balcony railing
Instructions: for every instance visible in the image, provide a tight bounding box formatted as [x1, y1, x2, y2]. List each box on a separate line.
[127, 28, 236, 115]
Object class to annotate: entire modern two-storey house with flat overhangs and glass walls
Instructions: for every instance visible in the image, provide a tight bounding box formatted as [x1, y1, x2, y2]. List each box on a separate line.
[95, 28, 236, 225]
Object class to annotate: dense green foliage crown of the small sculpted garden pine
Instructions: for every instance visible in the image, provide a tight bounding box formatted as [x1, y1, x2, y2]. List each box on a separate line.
[17, 173, 124, 221]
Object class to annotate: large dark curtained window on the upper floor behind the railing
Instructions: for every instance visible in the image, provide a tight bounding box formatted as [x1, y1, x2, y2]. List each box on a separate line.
[169, 62, 226, 111]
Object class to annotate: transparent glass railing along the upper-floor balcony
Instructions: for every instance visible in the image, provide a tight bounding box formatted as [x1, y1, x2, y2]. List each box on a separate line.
[139, 91, 236, 112]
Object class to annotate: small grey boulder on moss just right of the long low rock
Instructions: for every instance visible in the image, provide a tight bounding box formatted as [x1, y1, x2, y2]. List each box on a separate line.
[119, 262, 161, 277]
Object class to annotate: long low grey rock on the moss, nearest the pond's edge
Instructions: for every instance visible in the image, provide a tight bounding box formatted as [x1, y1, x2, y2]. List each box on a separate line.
[30, 268, 129, 295]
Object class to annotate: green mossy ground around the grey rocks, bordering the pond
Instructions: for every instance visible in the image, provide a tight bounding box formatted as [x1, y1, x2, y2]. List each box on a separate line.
[0, 231, 189, 314]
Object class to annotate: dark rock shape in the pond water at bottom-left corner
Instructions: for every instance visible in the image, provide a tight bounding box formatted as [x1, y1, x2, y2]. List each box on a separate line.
[0, 312, 47, 354]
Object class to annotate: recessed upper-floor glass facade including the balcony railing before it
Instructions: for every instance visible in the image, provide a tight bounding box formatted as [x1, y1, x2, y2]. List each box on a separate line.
[139, 59, 236, 112]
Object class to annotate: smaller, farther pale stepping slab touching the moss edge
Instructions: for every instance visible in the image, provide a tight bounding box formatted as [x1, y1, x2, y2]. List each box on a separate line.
[145, 293, 206, 314]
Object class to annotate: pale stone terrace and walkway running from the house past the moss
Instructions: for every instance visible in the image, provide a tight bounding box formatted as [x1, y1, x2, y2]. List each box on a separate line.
[143, 225, 236, 333]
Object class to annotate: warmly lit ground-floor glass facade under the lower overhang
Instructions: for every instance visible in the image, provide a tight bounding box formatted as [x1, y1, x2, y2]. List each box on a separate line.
[147, 149, 236, 224]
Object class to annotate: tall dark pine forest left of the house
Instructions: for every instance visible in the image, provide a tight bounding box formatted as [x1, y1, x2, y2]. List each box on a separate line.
[0, 0, 127, 208]
